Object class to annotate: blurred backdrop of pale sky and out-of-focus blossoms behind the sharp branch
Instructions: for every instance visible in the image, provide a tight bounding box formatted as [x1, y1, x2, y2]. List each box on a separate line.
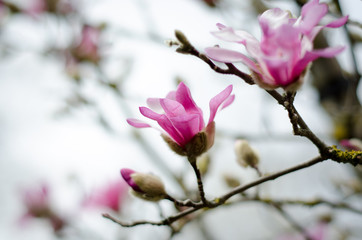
[0, 0, 362, 240]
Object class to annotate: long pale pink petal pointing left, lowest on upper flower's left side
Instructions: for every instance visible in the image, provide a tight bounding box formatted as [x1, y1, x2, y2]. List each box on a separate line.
[205, 47, 259, 72]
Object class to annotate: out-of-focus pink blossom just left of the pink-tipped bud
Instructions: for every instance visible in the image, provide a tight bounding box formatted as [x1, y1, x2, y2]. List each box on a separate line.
[83, 180, 128, 212]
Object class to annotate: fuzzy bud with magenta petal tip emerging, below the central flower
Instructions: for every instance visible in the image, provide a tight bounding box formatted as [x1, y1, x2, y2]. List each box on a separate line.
[121, 168, 167, 201]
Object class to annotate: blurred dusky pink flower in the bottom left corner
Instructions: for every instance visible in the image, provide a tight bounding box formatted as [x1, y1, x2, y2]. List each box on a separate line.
[20, 184, 65, 231]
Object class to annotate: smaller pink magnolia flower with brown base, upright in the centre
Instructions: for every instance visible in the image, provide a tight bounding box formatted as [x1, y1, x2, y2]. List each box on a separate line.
[127, 82, 235, 155]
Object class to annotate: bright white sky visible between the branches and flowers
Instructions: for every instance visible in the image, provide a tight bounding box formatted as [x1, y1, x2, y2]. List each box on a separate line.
[0, 0, 362, 240]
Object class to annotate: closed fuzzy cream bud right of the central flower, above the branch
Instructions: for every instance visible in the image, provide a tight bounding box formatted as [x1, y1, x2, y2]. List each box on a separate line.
[235, 139, 259, 168]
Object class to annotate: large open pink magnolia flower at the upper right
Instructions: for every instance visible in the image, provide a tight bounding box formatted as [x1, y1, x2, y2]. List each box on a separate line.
[205, 0, 348, 89]
